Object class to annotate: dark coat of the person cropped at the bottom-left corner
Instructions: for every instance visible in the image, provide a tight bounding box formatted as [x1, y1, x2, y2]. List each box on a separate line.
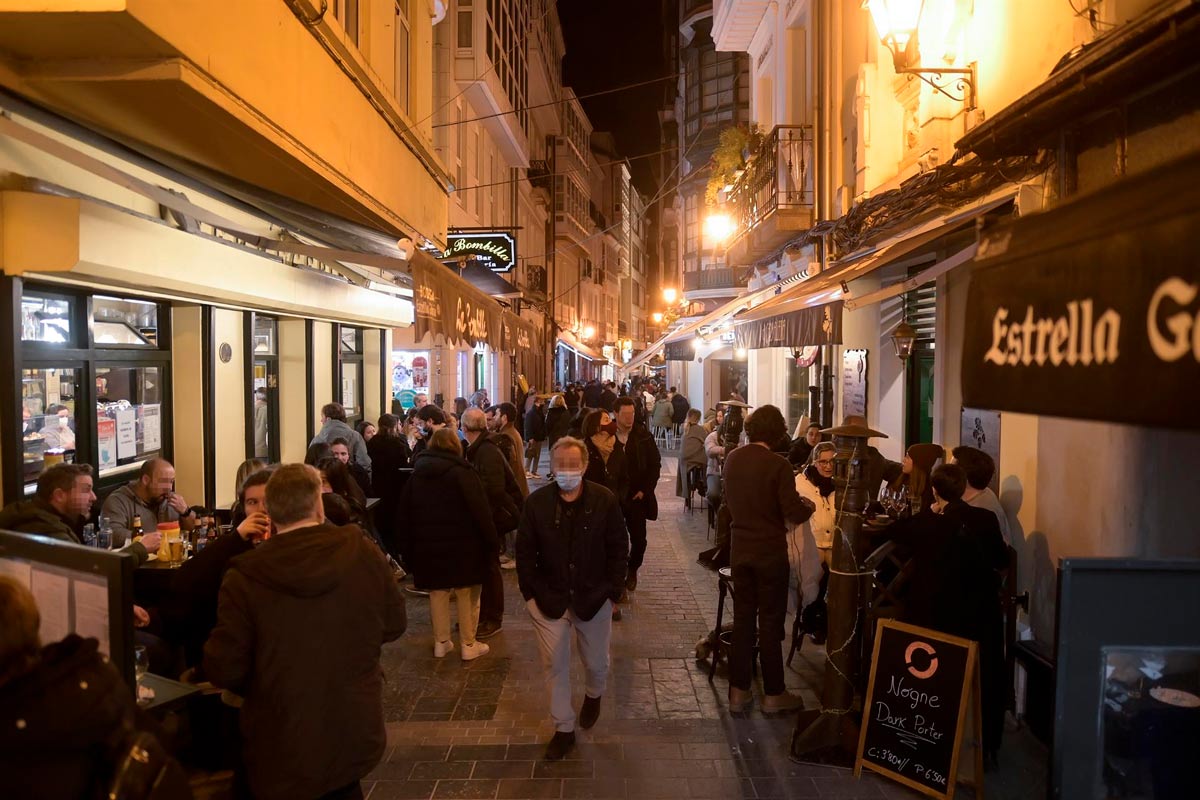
[0, 633, 191, 800]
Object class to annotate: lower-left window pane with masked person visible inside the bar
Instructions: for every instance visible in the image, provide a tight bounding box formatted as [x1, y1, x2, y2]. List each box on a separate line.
[20, 368, 79, 483]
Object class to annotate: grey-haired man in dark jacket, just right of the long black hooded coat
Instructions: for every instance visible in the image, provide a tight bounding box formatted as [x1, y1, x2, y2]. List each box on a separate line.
[462, 408, 522, 639]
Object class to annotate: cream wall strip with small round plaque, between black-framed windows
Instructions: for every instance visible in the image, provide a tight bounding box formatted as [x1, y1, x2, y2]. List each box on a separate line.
[212, 308, 251, 507]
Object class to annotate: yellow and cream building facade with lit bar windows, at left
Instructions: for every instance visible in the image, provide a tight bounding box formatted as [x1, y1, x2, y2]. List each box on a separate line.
[0, 0, 451, 506]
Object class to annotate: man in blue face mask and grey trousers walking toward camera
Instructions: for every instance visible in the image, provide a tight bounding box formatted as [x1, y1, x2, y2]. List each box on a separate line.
[517, 437, 629, 760]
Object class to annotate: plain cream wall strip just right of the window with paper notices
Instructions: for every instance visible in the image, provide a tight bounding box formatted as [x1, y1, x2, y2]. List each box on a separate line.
[170, 305, 205, 505]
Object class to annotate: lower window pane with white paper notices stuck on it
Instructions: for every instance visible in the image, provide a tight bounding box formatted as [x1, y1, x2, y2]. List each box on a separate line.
[96, 367, 163, 475]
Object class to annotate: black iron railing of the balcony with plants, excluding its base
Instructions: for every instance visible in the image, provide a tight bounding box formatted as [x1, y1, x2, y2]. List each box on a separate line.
[730, 125, 814, 236]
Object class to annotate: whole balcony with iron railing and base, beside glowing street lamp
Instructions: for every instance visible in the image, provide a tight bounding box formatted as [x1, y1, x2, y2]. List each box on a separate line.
[728, 125, 814, 264]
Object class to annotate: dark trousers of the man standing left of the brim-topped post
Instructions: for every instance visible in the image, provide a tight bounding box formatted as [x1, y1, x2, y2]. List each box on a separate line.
[730, 548, 788, 694]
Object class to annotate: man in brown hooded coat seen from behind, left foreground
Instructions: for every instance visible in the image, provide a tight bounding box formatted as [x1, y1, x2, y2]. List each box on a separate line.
[204, 464, 407, 800]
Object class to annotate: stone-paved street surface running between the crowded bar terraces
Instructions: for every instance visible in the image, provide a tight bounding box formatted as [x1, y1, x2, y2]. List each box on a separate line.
[364, 451, 1044, 800]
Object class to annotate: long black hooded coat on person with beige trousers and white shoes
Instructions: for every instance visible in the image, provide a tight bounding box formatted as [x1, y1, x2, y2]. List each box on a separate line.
[400, 450, 500, 590]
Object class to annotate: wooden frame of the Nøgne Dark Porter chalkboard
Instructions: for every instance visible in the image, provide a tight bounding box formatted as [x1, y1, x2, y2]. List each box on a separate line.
[854, 619, 984, 800]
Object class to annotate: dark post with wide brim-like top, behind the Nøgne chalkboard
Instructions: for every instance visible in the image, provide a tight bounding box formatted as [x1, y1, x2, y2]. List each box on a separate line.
[791, 425, 887, 766]
